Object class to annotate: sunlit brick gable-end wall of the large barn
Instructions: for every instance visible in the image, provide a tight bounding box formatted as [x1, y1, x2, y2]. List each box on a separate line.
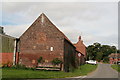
[19, 13, 64, 67]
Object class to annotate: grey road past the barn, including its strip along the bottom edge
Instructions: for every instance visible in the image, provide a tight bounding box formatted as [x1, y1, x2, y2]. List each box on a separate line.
[28, 64, 120, 80]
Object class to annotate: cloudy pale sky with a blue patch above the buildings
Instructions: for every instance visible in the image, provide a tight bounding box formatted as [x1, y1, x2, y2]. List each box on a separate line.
[0, 2, 118, 47]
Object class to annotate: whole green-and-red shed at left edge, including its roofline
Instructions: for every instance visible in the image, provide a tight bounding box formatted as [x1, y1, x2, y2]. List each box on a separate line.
[0, 27, 16, 66]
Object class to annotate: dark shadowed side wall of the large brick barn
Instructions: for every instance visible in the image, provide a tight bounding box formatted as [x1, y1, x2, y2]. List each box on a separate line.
[64, 40, 76, 72]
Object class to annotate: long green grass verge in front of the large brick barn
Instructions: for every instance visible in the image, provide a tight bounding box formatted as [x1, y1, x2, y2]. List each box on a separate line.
[2, 64, 97, 78]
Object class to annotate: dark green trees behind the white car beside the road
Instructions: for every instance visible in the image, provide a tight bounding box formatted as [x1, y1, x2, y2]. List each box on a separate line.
[87, 42, 119, 62]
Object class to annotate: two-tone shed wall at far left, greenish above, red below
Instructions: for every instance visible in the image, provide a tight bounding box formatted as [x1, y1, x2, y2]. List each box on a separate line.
[0, 35, 14, 64]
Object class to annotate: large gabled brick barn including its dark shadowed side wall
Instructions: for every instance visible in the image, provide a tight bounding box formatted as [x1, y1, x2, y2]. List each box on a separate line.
[18, 13, 77, 72]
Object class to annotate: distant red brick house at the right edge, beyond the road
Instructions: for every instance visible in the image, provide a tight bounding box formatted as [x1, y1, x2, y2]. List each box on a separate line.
[109, 53, 120, 64]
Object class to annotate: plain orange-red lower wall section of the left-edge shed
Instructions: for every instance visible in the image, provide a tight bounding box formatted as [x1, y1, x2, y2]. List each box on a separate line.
[0, 53, 13, 64]
